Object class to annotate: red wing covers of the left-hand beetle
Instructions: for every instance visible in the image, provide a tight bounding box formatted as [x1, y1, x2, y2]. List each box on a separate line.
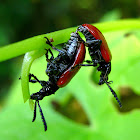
[57, 42, 86, 87]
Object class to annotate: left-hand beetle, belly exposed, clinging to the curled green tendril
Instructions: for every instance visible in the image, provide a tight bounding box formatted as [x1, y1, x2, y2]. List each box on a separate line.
[29, 33, 86, 131]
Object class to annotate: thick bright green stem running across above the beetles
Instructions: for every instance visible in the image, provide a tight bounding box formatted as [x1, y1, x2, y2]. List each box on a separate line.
[0, 19, 140, 62]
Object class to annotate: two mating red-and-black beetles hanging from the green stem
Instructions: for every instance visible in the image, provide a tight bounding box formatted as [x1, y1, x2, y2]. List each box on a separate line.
[29, 24, 121, 131]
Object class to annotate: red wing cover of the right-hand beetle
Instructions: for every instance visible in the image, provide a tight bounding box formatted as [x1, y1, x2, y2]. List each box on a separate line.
[82, 24, 112, 63]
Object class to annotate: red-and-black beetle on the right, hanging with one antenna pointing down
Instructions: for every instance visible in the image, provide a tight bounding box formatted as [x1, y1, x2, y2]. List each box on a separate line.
[73, 24, 122, 107]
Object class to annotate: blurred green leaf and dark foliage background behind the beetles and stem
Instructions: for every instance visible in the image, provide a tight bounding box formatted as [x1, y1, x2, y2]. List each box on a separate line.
[0, 0, 140, 140]
